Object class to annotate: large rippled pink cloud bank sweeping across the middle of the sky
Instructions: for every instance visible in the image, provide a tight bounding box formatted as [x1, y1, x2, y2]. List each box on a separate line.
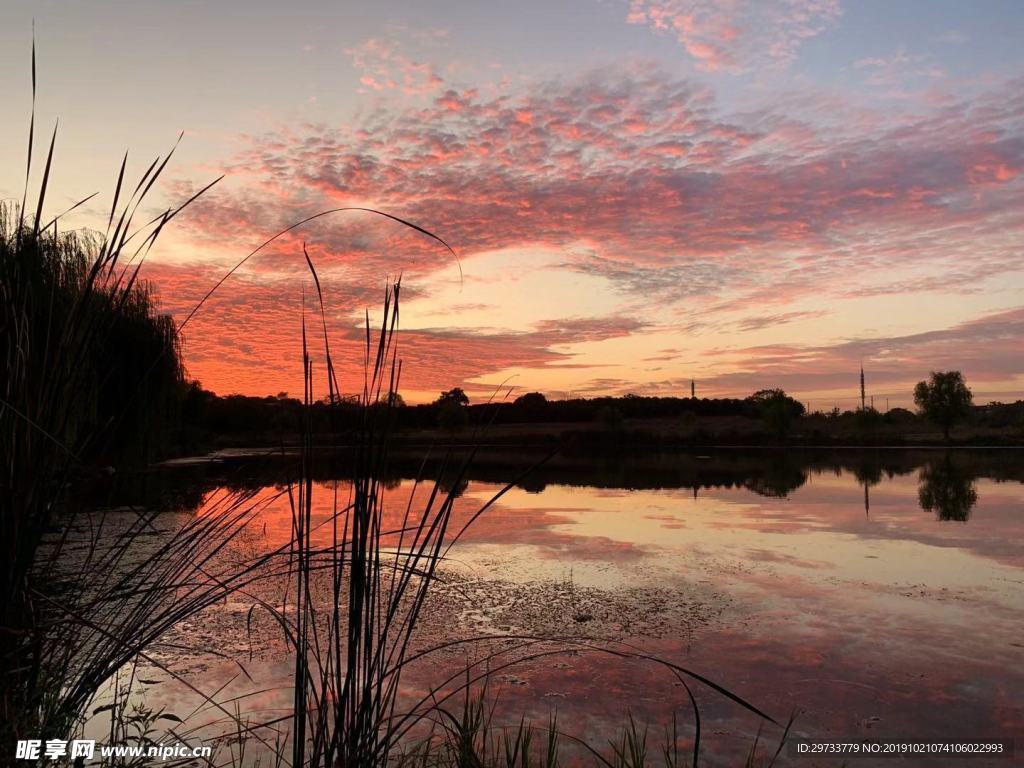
[151, 66, 1024, 399]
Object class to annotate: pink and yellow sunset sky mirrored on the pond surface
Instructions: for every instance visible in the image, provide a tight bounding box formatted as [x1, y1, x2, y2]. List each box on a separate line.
[176, 473, 1024, 764]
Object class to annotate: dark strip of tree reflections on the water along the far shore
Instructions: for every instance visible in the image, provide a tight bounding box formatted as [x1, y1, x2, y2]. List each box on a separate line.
[119, 447, 1024, 520]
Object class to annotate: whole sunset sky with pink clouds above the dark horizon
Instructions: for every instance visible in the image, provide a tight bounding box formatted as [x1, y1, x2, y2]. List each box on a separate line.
[0, 0, 1024, 410]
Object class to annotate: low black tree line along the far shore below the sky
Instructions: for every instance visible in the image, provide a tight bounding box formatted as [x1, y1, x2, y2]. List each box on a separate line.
[174, 371, 1024, 448]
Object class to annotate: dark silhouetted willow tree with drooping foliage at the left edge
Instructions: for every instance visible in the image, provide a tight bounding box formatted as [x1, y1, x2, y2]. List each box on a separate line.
[0, 203, 187, 466]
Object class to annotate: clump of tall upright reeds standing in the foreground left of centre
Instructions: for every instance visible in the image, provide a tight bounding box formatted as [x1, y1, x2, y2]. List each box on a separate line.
[282, 274, 552, 766]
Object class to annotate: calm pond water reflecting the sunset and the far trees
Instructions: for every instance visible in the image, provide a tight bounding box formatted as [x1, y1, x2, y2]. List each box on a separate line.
[86, 451, 1024, 765]
